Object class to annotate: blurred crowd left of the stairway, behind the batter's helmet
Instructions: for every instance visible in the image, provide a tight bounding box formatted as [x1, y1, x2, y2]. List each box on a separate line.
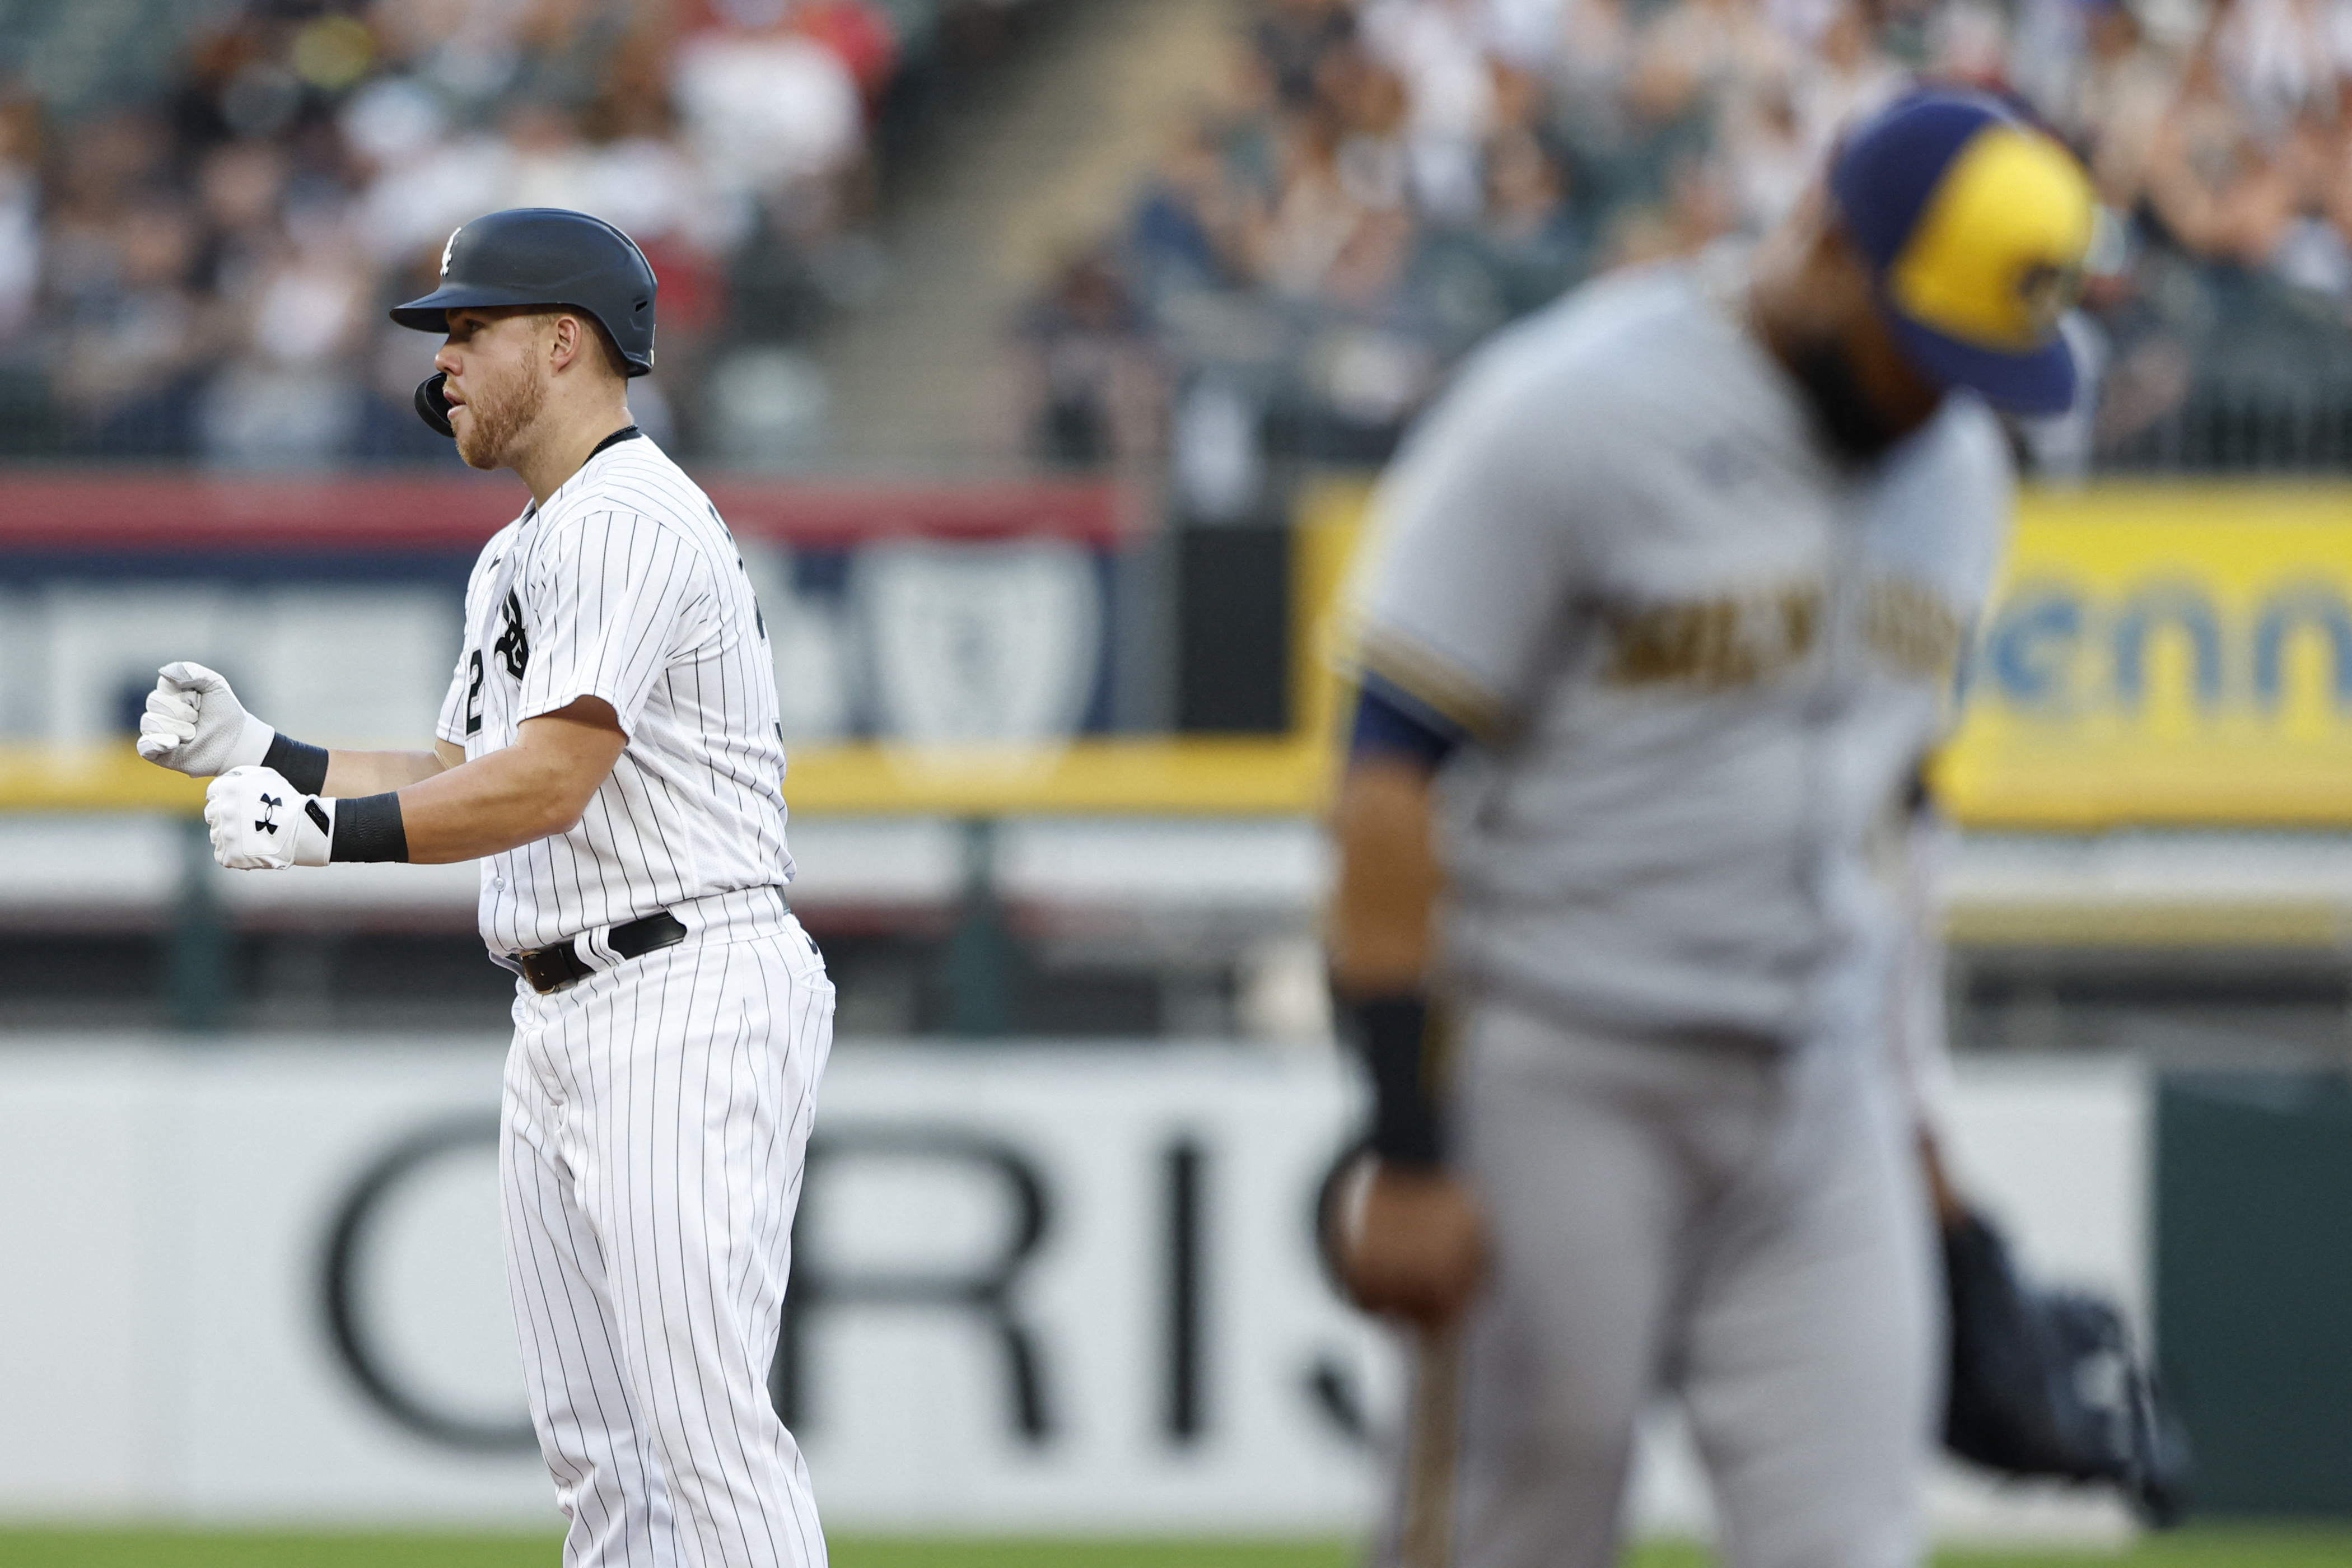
[0, 0, 1002, 468]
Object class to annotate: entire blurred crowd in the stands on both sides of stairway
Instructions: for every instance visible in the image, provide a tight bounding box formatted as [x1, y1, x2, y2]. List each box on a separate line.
[0, 0, 2352, 479]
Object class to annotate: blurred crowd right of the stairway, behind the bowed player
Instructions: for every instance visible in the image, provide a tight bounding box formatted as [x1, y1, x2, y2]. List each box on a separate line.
[1023, 0, 2352, 501]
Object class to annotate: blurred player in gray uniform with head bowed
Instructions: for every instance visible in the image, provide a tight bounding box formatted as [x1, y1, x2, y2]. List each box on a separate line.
[1331, 90, 2093, 1568]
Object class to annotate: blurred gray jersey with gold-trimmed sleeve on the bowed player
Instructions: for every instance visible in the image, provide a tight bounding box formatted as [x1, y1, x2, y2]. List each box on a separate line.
[1350, 254, 2011, 1042]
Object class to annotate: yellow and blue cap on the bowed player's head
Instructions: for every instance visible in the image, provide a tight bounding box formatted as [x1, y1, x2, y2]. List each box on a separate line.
[1830, 87, 2098, 414]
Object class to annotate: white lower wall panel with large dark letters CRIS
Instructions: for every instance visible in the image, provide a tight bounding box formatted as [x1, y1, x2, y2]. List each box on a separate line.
[0, 1039, 2148, 1537]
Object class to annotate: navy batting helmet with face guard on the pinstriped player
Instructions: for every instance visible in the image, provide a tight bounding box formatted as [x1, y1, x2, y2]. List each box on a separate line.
[393, 207, 656, 435]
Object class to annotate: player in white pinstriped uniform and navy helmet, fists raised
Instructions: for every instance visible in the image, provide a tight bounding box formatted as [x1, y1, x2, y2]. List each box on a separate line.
[139, 209, 833, 1568]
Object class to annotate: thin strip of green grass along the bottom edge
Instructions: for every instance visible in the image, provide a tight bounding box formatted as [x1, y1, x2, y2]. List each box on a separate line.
[0, 1528, 2352, 1568]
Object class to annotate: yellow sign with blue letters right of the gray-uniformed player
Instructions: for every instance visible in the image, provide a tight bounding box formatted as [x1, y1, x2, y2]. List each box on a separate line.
[1940, 484, 2352, 828]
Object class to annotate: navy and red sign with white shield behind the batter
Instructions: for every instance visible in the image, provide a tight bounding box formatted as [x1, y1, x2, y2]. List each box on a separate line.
[0, 475, 1133, 771]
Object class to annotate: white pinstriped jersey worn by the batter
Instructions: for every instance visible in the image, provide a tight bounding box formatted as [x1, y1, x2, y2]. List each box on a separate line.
[437, 435, 792, 957]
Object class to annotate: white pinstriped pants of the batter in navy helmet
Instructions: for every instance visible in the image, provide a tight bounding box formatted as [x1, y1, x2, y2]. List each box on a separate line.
[498, 914, 833, 1568]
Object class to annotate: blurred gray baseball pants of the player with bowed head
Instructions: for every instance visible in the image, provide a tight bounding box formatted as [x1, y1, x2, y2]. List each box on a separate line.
[1380, 1006, 1940, 1568]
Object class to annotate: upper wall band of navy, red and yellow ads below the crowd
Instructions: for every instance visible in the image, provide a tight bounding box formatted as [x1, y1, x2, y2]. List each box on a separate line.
[32, 475, 2352, 832]
